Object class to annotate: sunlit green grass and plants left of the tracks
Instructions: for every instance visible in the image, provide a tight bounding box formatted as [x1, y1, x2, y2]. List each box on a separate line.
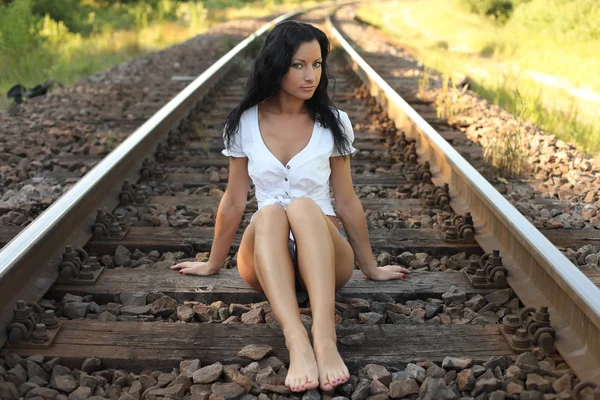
[0, 0, 324, 109]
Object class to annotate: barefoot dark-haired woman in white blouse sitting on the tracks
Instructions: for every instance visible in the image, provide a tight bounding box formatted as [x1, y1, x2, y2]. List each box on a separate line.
[171, 21, 409, 392]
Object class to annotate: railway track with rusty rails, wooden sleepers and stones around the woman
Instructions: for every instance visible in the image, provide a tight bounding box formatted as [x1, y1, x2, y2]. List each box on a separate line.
[0, 3, 600, 400]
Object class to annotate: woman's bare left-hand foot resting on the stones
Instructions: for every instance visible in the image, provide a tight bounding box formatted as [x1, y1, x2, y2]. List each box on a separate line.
[285, 328, 319, 392]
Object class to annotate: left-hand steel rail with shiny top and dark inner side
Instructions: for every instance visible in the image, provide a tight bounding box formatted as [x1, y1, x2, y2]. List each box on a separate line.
[0, 7, 304, 348]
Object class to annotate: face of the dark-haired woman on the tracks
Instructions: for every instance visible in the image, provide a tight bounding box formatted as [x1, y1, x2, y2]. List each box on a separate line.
[281, 39, 323, 100]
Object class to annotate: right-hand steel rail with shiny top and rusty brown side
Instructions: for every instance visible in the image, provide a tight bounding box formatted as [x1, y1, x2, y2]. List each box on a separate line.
[327, 9, 600, 382]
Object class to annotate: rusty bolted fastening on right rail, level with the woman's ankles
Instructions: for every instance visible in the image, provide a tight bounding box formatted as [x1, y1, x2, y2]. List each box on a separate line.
[500, 306, 556, 355]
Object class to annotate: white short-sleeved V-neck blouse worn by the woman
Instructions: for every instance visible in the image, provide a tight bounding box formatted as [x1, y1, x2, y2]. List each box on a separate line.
[222, 106, 356, 239]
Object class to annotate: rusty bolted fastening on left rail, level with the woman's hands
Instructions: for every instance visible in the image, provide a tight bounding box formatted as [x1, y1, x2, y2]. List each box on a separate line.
[57, 246, 104, 285]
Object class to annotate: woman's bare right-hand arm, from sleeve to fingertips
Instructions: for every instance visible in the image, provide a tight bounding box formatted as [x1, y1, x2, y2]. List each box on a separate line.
[329, 156, 410, 280]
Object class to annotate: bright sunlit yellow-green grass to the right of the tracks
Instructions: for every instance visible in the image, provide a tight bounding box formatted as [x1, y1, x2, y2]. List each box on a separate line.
[358, 0, 600, 153]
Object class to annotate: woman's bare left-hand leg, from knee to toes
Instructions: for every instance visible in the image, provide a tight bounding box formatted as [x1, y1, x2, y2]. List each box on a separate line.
[253, 206, 319, 391]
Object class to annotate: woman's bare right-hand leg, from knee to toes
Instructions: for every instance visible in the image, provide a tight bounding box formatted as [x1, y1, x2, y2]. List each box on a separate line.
[287, 198, 353, 391]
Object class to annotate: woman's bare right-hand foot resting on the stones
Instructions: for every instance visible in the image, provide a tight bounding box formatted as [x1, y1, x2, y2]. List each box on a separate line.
[313, 334, 350, 392]
